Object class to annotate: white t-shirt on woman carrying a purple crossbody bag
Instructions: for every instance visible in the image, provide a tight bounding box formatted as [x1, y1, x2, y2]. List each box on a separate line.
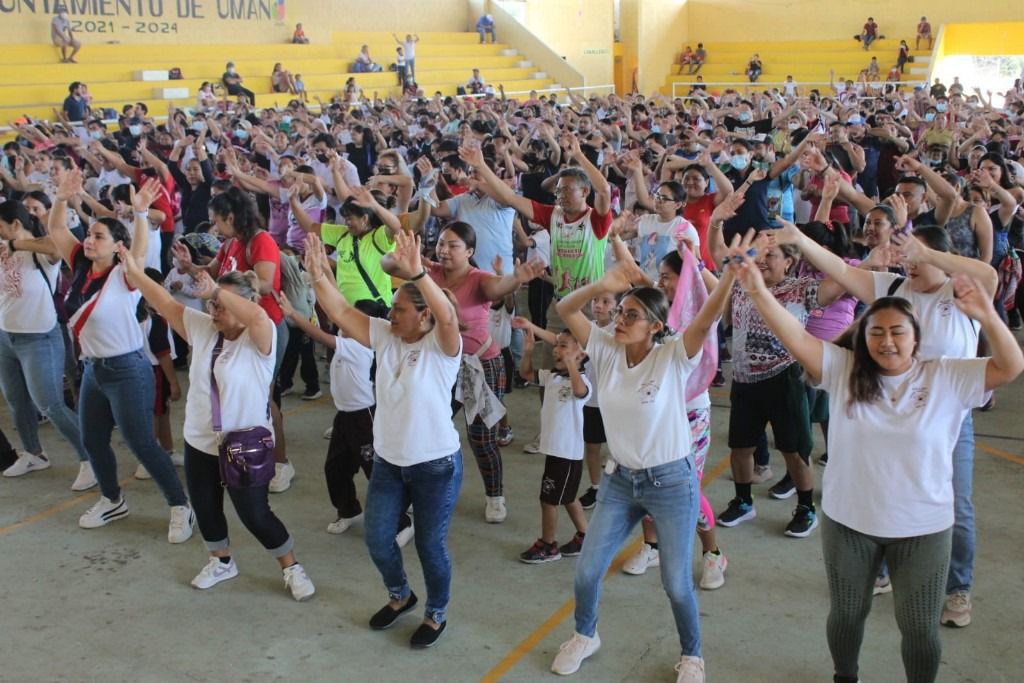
[181, 308, 278, 455]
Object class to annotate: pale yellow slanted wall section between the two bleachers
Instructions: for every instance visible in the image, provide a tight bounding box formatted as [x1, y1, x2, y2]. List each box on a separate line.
[516, 0, 613, 85]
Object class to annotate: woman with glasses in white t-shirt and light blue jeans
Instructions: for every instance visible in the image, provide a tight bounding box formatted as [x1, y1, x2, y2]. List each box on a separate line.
[551, 254, 732, 680]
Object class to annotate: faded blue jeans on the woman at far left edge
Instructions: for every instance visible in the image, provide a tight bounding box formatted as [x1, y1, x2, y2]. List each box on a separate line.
[0, 326, 89, 461]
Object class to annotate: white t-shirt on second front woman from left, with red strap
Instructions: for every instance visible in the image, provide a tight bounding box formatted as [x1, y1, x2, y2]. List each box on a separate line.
[69, 264, 143, 360]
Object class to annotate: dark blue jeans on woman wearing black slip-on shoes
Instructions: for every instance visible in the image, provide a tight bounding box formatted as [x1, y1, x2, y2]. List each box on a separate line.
[364, 451, 462, 624]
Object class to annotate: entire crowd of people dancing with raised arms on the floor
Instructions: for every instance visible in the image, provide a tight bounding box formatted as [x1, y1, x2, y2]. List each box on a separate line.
[0, 49, 1024, 683]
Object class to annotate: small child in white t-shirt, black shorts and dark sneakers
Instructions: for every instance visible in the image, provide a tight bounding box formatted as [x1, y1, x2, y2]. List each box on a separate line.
[519, 328, 591, 564]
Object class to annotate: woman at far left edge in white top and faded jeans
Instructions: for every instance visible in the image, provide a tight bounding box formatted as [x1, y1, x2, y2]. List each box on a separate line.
[0, 201, 96, 490]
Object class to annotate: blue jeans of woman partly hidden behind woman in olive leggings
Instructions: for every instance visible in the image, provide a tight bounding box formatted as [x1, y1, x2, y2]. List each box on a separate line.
[946, 413, 975, 594]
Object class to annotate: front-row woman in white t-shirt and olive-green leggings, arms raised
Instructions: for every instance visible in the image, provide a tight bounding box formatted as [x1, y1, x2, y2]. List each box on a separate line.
[730, 233, 1024, 683]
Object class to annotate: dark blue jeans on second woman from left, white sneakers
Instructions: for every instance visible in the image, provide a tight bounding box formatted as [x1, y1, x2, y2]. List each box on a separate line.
[78, 349, 188, 506]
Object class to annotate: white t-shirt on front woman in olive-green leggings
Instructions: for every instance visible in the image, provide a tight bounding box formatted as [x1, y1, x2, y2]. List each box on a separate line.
[818, 343, 988, 539]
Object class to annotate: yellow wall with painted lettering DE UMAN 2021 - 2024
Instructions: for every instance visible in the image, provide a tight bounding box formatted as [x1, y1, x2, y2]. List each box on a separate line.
[0, 0, 468, 45]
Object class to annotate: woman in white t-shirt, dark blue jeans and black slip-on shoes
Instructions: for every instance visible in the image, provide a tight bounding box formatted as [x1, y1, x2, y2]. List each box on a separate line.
[305, 228, 463, 648]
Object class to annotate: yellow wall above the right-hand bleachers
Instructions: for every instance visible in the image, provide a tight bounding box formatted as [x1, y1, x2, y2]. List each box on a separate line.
[677, 0, 1024, 42]
